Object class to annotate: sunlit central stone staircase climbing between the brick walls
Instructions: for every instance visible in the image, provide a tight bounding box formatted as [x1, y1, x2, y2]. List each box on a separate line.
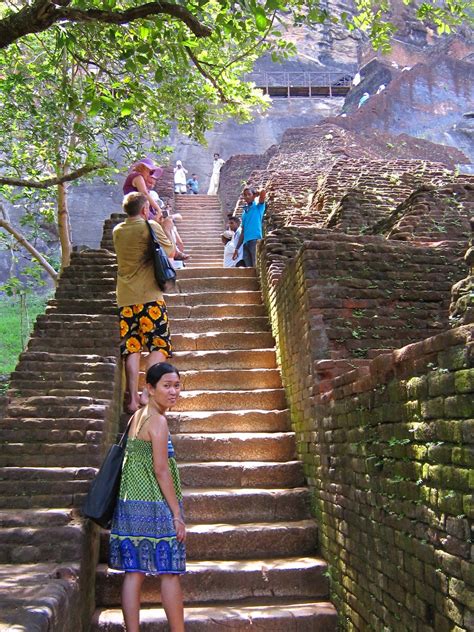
[92, 196, 337, 632]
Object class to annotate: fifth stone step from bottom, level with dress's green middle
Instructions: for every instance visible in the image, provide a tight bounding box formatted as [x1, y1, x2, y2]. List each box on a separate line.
[179, 461, 304, 488]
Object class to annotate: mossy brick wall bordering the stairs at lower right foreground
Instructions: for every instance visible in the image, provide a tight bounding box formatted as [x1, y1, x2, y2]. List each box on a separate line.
[259, 239, 474, 632]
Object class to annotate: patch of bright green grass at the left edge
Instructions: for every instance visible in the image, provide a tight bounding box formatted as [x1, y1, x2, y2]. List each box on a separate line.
[0, 294, 49, 389]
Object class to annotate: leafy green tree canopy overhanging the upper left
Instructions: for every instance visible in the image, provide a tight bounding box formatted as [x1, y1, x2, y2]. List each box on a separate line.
[0, 0, 472, 282]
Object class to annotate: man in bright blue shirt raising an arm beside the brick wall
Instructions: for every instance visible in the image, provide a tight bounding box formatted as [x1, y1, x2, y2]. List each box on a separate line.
[232, 187, 266, 268]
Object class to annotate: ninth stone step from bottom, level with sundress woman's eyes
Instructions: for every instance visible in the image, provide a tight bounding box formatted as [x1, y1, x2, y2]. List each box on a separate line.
[171, 369, 282, 391]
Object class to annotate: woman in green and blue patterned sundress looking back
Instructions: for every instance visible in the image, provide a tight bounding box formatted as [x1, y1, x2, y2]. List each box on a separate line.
[109, 362, 186, 632]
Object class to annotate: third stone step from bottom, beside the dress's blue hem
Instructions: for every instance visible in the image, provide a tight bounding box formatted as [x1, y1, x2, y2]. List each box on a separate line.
[100, 520, 318, 563]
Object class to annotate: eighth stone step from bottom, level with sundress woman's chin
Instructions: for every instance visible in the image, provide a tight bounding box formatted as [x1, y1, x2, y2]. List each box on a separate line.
[173, 388, 286, 412]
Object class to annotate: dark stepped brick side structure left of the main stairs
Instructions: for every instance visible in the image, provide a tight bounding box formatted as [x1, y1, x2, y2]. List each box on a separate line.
[0, 250, 120, 632]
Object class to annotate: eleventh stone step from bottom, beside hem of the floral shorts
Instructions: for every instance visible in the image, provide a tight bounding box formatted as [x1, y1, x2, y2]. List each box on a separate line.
[172, 331, 274, 351]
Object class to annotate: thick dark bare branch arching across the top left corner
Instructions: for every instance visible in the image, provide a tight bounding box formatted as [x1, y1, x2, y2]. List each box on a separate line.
[0, 0, 212, 48]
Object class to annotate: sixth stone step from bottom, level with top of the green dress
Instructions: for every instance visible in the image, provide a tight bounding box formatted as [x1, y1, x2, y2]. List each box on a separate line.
[173, 432, 296, 462]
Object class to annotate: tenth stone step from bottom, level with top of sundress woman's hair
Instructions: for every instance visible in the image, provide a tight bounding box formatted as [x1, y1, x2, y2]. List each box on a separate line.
[168, 349, 276, 371]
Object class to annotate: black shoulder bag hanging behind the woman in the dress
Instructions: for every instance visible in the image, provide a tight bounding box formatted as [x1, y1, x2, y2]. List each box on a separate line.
[82, 415, 133, 529]
